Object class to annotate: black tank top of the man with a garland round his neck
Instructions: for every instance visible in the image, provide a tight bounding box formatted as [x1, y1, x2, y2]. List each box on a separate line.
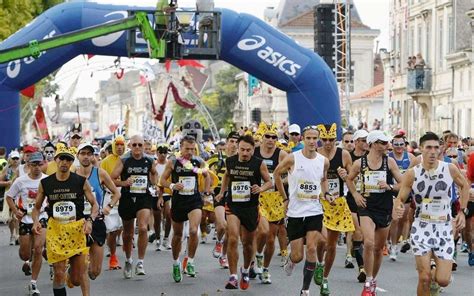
[171, 156, 203, 200]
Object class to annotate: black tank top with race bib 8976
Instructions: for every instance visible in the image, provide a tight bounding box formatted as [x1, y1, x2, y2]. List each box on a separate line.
[226, 155, 262, 208]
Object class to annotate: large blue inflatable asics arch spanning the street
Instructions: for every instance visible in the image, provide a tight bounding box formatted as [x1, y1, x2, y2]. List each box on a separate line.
[0, 2, 340, 149]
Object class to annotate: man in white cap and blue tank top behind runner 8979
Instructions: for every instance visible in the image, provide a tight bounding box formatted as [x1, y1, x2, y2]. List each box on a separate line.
[76, 143, 120, 295]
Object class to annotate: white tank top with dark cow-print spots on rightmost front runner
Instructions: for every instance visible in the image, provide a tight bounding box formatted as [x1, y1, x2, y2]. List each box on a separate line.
[412, 161, 453, 223]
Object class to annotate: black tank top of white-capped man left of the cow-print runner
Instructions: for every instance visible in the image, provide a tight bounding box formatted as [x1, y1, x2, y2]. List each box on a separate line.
[360, 155, 393, 210]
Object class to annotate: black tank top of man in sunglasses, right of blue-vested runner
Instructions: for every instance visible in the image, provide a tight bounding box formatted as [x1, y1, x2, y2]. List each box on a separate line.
[120, 156, 153, 197]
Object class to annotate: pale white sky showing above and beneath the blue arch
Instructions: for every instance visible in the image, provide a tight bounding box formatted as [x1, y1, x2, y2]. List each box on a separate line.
[54, 0, 390, 100]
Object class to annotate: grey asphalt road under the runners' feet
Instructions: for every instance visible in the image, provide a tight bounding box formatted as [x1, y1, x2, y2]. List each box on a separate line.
[0, 225, 474, 296]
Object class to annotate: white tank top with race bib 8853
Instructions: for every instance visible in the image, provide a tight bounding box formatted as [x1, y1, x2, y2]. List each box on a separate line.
[287, 150, 325, 218]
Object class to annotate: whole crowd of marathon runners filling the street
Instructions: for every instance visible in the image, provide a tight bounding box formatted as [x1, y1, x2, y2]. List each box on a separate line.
[0, 123, 474, 296]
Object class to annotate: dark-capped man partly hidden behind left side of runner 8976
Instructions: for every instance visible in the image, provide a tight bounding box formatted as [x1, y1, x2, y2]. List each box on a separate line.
[207, 131, 239, 268]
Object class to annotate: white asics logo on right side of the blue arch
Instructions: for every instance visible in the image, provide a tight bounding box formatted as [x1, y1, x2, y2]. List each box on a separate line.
[237, 35, 301, 77]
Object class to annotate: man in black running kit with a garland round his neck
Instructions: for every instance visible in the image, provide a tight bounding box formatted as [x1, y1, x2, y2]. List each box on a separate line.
[160, 136, 211, 283]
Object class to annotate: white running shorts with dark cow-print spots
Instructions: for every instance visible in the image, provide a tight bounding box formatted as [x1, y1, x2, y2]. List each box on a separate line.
[410, 219, 454, 260]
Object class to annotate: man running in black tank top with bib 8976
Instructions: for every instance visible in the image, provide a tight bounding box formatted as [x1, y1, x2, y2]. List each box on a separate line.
[216, 135, 273, 290]
